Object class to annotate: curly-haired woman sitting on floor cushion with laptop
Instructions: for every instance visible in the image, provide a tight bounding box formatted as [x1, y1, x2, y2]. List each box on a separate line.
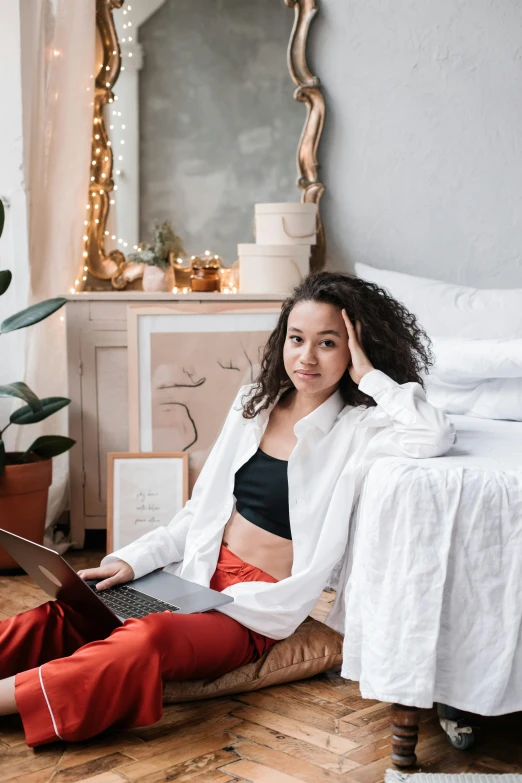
[0, 272, 455, 746]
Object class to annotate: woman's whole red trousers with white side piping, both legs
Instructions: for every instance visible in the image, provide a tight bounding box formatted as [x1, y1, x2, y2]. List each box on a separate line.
[0, 545, 278, 747]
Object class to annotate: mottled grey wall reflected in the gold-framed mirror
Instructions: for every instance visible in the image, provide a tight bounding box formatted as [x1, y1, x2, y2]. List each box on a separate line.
[139, 0, 306, 264]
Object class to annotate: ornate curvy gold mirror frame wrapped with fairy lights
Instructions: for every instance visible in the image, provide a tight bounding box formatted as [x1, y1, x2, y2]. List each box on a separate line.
[83, 0, 325, 290]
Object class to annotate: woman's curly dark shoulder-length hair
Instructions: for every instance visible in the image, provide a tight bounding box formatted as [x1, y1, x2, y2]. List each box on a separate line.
[242, 272, 434, 419]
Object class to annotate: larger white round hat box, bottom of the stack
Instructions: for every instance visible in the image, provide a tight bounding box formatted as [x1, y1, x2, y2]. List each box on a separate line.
[237, 244, 310, 294]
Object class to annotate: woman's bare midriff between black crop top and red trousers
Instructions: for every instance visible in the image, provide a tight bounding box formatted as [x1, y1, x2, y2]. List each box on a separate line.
[222, 506, 294, 581]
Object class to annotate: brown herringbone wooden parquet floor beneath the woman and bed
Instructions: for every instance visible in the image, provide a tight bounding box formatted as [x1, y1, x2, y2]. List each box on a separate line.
[0, 552, 522, 783]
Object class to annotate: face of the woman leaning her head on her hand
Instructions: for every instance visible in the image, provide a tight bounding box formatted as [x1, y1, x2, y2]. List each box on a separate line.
[283, 302, 351, 394]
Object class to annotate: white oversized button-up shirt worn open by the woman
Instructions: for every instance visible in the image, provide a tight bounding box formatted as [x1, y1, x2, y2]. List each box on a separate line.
[102, 369, 450, 639]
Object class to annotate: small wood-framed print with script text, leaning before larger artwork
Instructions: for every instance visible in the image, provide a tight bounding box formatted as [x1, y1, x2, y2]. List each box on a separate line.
[107, 452, 188, 552]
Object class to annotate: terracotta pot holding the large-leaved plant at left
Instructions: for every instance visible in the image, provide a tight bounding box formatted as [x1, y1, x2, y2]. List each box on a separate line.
[0, 452, 53, 569]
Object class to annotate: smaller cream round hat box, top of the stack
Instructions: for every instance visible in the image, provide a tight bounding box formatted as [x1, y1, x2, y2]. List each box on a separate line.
[255, 202, 317, 245]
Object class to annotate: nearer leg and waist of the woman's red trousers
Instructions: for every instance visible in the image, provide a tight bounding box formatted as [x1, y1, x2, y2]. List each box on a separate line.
[10, 548, 277, 746]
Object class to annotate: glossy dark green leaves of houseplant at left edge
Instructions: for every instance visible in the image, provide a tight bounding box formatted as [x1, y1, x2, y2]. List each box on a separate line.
[0, 200, 76, 475]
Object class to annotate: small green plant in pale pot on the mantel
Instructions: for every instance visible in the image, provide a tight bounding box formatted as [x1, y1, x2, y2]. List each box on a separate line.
[127, 220, 185, 292]
